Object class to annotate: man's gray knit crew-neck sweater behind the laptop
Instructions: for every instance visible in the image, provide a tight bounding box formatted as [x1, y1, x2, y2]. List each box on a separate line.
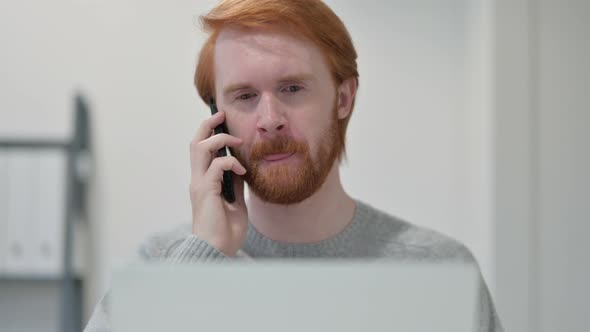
[84, 201, 504, 332]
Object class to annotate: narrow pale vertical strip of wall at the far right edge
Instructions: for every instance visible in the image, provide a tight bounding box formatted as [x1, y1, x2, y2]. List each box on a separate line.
[535, 0, 590, 332]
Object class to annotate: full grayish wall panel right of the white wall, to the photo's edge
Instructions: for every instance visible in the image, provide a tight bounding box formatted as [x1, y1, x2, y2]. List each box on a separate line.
[494, 0, 590, 332]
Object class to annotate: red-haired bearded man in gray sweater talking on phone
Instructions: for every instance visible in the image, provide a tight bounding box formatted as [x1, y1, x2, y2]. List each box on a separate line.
[86, 0, 502, 332]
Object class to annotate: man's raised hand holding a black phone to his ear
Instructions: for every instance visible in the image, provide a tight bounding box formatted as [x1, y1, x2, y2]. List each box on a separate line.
[190, 100, 248, 256]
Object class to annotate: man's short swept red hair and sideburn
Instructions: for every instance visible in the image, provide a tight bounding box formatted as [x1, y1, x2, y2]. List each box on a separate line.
[195, 0, 359, 157]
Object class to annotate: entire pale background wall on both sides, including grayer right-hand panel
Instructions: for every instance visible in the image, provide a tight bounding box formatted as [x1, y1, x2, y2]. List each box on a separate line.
[0, 0, 590, 332]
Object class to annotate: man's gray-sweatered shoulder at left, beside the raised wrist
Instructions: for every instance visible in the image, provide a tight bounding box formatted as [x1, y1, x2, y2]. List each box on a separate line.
[139, 223, 192, 261]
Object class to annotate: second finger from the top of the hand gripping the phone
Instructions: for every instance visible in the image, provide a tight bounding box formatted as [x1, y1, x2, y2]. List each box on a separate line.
[191, 134, 242, 177]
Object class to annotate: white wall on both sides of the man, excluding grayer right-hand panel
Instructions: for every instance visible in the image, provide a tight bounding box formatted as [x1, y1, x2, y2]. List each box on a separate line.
[0, 0, 500, 322]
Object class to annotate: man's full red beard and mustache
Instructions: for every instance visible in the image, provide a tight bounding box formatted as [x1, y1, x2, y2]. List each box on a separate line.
[235, 109, 343, 205]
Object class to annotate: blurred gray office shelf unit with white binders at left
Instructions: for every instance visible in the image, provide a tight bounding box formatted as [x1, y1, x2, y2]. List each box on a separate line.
[0, 95, 92, 332]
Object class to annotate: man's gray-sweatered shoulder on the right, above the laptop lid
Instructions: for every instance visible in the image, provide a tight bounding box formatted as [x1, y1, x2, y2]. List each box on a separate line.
[357, 201, 474, 262]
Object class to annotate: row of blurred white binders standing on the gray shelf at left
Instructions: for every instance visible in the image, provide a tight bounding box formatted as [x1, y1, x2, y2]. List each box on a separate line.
[0, 150, 66, 278]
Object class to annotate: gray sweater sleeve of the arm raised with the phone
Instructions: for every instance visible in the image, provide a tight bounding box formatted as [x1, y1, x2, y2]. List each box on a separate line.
[84, 235, 235, 332]
